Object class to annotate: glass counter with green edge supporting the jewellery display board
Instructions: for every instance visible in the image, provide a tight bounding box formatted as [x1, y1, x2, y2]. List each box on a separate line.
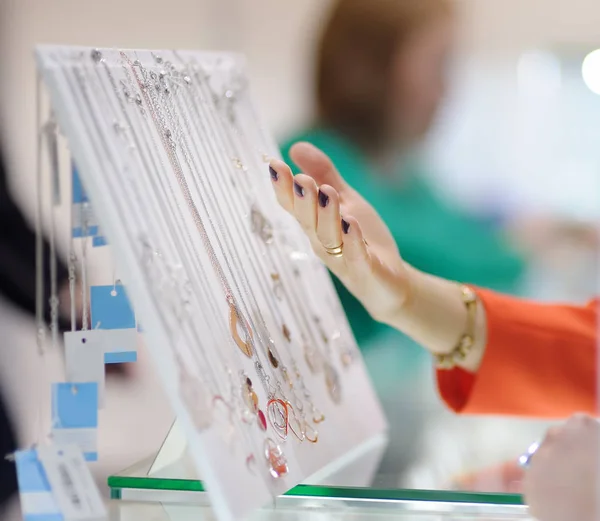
[108, 452, 530, 521]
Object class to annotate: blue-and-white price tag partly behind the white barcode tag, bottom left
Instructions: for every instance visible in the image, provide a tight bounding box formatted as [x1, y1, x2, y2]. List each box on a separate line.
[15, 449, 64, 521]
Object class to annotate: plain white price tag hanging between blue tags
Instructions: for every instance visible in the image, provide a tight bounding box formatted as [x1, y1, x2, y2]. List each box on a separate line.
[64, 330, 106, 408]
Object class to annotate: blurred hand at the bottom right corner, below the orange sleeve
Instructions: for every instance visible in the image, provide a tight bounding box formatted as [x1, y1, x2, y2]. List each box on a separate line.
[523, 415, 600, 521]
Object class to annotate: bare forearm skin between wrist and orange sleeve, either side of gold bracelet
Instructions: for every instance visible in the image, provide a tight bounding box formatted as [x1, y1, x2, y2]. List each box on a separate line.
[387, 268, 487, 372]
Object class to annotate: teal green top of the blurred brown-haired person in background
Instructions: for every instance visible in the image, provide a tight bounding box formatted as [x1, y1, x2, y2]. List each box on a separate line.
[282, 129, 525, 354]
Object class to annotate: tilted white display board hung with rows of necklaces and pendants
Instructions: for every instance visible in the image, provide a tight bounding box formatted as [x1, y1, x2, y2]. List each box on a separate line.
[37, 46, 386, 520]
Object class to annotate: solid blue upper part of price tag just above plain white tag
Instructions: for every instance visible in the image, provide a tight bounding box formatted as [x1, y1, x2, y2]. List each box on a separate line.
[90, 284, 136, 329]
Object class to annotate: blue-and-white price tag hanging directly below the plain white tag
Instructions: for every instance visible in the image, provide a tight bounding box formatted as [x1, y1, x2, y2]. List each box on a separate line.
[52, 382, 98, 461]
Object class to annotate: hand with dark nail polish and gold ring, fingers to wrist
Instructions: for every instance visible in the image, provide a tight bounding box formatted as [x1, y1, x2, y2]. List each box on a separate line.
[271, 143, 410, 323]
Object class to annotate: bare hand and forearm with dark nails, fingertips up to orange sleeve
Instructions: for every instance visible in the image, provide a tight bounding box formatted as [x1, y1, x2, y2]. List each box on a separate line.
[270, 143, 486, 371]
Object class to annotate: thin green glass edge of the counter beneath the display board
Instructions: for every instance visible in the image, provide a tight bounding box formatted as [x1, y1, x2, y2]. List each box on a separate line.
[108, 476, 523, 505]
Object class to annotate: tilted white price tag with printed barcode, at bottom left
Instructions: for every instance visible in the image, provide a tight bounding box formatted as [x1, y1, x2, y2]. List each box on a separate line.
[37, 445, 107, 521]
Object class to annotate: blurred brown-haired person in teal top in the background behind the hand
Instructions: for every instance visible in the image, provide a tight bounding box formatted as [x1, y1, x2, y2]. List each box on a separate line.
[282, 0, 525, 482]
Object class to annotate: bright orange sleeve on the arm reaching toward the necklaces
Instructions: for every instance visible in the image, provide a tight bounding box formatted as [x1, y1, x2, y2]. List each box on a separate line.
[437, 290, 599, 418]
